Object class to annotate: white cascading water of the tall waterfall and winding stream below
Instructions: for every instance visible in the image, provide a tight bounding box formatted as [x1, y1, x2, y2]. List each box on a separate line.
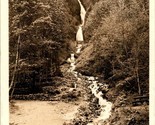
[68, 0, 112, 125]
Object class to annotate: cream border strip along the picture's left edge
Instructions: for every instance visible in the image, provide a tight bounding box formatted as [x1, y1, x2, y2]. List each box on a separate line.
[0, 0, 9, 125]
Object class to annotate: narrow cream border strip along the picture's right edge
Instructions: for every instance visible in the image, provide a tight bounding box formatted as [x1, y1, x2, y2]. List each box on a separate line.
[149, 0, 155, 125]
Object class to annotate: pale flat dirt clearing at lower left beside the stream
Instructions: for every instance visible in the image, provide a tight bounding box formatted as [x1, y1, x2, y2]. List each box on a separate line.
[10, 101, 79, 125]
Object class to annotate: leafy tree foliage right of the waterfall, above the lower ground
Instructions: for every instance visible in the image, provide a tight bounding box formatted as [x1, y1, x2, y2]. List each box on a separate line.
[79, 0, 149, 94]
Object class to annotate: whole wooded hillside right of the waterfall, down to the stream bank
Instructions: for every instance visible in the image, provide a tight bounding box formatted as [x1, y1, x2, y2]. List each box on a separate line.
[76, 0, 149, 125]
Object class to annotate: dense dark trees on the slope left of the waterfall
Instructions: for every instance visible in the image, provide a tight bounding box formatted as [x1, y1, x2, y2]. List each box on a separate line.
[9, 0, 75, 92]
